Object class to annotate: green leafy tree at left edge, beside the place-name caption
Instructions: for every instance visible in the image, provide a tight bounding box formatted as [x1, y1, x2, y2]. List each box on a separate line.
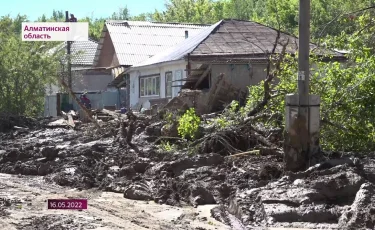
[0, 16, 62, 116]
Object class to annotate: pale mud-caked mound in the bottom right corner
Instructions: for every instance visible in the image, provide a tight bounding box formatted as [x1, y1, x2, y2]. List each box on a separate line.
[339, 183, 375, 229]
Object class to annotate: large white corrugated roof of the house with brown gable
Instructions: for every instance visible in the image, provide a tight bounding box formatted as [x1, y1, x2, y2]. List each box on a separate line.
[94, 20, 209, 66]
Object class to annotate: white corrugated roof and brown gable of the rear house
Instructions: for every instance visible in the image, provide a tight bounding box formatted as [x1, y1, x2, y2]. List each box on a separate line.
[93, 20, 212, 87]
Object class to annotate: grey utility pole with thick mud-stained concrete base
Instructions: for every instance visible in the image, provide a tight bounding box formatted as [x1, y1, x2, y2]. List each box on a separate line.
[284, 0, 320, 171]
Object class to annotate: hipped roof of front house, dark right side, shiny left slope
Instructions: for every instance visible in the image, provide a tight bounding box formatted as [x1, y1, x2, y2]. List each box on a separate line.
[133, 19, 344, 67]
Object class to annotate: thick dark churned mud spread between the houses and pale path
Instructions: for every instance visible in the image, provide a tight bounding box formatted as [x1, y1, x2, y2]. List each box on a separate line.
[0, 117, 375, 229]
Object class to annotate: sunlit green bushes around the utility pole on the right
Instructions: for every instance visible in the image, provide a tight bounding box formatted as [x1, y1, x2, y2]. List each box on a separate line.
[247, 14, 375, 152]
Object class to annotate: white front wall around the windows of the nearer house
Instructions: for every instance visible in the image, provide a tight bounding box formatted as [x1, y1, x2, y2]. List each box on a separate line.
[129, 61, 186, 109]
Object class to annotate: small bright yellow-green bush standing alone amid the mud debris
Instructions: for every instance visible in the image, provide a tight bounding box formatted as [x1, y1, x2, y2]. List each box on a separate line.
[177, 108, 201, 139]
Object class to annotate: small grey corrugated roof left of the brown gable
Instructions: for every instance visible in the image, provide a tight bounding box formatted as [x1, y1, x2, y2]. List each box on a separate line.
[50, 39, 98, 66]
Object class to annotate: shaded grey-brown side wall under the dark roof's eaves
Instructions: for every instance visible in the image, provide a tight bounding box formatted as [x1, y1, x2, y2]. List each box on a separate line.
[211, 64, 267, 89]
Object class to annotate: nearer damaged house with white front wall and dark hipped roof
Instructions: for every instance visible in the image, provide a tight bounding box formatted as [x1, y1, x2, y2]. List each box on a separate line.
[113, 19, 344, 113]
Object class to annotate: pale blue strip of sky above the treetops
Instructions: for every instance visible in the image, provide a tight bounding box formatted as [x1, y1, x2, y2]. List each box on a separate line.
[0, 0, 165, 21]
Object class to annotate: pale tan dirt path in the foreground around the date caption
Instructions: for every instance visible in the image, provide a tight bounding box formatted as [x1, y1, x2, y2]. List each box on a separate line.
[0, 174, 230, 230]
